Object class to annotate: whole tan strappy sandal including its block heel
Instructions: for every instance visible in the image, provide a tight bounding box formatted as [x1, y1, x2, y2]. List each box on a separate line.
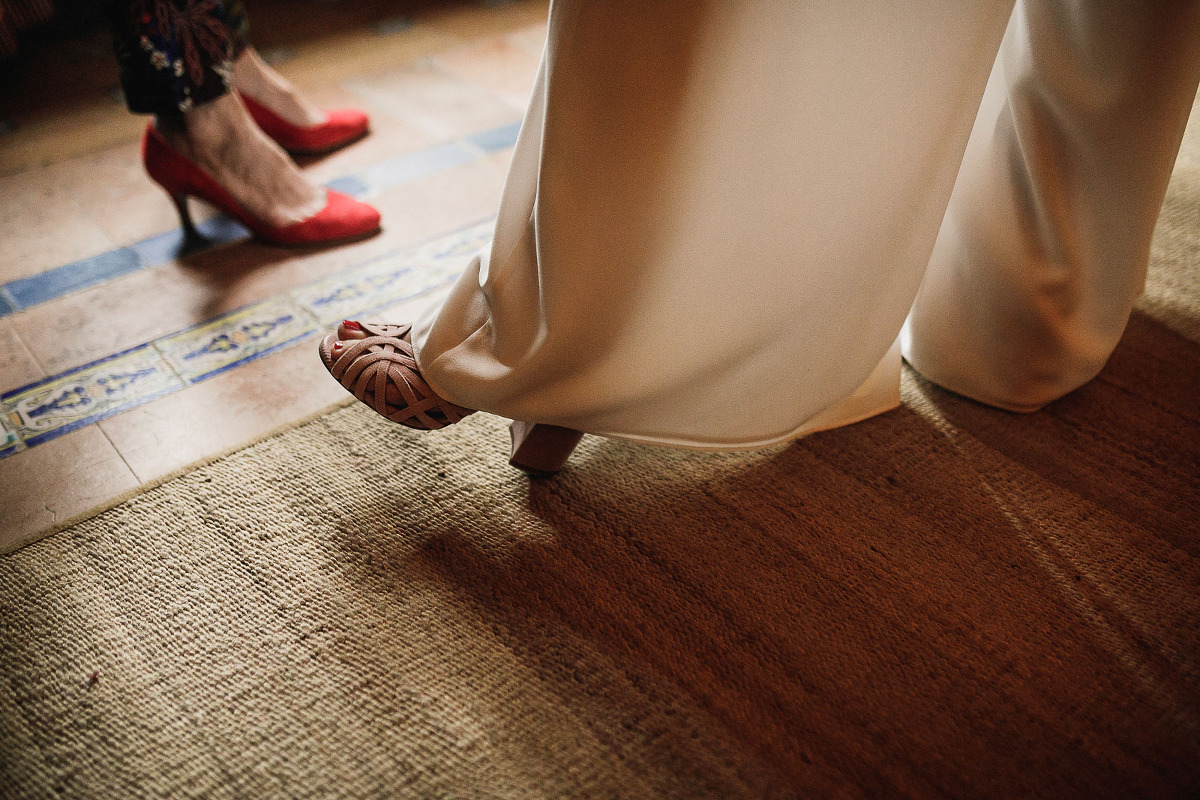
[318, 323, 583, 477]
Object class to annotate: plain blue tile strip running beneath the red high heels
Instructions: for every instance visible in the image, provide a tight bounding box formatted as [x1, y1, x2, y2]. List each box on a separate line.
[0, 122, 521, 317]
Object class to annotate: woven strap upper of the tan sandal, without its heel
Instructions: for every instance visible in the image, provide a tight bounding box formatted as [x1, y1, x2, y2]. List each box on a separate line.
[329, 323, 474, 431]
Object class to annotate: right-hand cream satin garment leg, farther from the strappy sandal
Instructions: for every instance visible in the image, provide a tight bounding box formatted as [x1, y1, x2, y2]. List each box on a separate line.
[904, 0, 1200, 411]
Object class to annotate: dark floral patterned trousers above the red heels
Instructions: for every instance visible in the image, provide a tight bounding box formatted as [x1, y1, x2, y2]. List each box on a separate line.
[104, 0, 250, 115]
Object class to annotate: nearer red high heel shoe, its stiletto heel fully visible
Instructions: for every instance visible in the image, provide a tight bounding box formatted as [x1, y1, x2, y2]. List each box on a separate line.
[142, 124, 379, 245]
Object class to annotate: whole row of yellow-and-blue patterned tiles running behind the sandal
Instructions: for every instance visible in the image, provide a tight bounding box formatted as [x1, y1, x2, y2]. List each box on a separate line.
[0, 219, 494, 458]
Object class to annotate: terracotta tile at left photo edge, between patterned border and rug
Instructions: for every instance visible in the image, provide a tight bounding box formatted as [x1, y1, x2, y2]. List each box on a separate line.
[0, 426, 138, 553]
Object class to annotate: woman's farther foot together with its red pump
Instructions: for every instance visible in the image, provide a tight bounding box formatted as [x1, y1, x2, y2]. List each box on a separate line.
[233, 47, 370, 156]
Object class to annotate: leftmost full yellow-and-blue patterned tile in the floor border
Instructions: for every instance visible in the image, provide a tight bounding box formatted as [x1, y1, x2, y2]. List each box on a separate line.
[0, 345, 182, 446]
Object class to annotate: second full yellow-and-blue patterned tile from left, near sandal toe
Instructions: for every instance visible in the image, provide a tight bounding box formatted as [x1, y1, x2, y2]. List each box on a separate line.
[155, 297, 317, 383]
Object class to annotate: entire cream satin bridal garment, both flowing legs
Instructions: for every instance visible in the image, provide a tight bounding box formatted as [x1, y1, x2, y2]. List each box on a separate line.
[413, 0, 1200, 449]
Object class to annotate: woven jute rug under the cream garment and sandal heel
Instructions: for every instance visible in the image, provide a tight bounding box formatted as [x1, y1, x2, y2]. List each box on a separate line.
[0, 113, 1200, 799]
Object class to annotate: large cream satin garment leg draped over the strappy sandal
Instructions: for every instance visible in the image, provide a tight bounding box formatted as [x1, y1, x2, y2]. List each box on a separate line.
[410, 0, 1012, 447]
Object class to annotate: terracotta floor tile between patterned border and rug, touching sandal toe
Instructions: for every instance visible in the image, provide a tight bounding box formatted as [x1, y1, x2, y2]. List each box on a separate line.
[100, 331, 347, 482]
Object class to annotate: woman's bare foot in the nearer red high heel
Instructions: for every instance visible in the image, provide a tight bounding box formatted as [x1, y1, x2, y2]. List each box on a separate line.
[156, 94, 326, 228]
